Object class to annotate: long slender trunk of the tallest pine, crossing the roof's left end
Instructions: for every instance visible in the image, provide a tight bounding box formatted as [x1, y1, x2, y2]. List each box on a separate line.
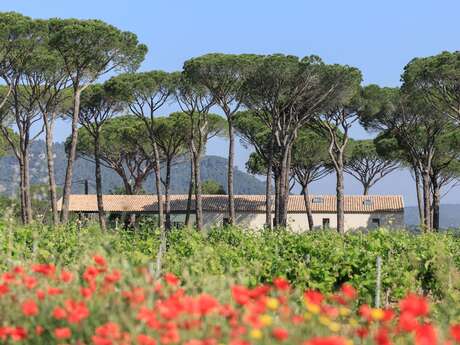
[61, 89, 81, 223]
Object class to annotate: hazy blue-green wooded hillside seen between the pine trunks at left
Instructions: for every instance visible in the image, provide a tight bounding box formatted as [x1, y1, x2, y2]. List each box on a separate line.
[0, 141, 265, 195]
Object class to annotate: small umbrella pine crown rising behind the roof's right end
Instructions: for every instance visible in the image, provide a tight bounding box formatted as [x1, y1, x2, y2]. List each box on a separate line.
[344, 140, 399, 195]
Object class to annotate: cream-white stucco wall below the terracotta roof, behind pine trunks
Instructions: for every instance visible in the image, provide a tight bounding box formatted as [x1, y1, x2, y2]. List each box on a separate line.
[171, 212, 404, 232]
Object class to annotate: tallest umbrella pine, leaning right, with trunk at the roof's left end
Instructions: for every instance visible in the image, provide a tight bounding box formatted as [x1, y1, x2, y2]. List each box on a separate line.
[49, 19, 147, 222]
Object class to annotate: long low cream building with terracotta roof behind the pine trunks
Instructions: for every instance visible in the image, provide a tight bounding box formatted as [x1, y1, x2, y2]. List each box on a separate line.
[59, 195, 404, 232]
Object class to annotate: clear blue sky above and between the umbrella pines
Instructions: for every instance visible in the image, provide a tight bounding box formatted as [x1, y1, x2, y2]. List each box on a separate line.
[0, 0, 460, 205]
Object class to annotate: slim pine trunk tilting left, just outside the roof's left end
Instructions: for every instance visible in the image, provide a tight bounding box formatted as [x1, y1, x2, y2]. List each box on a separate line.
[43, 114, 59, 226]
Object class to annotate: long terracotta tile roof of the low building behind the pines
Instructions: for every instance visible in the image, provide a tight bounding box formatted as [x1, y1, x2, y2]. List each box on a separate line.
[58, 194, 404, 213]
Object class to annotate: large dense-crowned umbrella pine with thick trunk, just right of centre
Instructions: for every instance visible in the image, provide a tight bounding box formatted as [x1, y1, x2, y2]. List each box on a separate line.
[242, 55, 348, 227]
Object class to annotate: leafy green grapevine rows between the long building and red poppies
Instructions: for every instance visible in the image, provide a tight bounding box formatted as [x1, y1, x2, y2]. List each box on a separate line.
[0, 220, 460, 302]
